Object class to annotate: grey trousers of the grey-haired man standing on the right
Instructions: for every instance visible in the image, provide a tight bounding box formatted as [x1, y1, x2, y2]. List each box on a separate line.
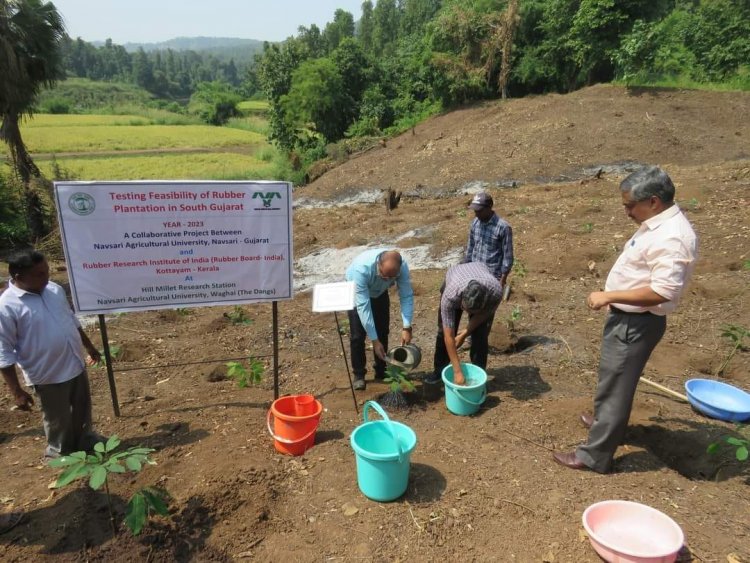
[576, 312, 667, 473]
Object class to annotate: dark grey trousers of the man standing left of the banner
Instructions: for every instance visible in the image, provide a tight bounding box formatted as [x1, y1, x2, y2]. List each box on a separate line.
[34, 371, 102, 458]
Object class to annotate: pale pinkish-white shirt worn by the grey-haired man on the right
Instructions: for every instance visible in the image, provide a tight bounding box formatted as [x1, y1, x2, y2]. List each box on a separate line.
[605, 205, 698, 315]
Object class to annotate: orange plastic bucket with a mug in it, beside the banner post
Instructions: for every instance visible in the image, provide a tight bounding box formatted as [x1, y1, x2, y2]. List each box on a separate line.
[266, 395, 323, 456]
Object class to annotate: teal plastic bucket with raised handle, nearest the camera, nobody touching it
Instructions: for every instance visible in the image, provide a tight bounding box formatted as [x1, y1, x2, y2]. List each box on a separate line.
[351, 401, 417, 502]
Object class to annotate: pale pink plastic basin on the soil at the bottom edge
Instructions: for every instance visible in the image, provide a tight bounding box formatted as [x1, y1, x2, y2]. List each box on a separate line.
[583, 500, 685, 563]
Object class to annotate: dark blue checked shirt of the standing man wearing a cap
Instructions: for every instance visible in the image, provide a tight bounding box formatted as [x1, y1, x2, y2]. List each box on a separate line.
[464, 213, 513, 278]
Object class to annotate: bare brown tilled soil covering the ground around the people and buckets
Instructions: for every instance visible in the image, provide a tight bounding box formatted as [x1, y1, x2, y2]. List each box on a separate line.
[0, 86, 750, 562]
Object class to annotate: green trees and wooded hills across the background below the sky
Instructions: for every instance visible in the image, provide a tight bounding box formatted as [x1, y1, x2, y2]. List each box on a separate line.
[0, 0, 750, 247]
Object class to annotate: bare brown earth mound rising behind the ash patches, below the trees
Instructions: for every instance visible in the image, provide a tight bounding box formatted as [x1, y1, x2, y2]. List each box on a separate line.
[303, 85, 750, 197]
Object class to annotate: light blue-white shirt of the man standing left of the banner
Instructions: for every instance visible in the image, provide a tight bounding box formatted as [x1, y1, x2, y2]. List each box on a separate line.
[0, 282, 85, 385]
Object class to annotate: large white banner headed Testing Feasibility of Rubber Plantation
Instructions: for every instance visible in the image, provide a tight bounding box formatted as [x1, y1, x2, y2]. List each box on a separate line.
[55, 181, 294, 313]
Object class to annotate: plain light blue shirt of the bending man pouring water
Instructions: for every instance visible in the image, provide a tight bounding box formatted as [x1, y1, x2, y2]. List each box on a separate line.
[346, 248, 414, 340]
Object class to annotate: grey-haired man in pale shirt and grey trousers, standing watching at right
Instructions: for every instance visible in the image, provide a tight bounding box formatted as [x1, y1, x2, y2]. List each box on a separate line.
[553, 166, 698, 473]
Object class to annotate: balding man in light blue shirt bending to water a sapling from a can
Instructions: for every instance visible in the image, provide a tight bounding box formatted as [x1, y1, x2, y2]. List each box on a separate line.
[346, 248, 414, 391]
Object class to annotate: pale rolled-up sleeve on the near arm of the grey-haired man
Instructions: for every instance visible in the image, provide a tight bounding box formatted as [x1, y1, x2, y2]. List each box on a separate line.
[646, 238, 695, 301]
